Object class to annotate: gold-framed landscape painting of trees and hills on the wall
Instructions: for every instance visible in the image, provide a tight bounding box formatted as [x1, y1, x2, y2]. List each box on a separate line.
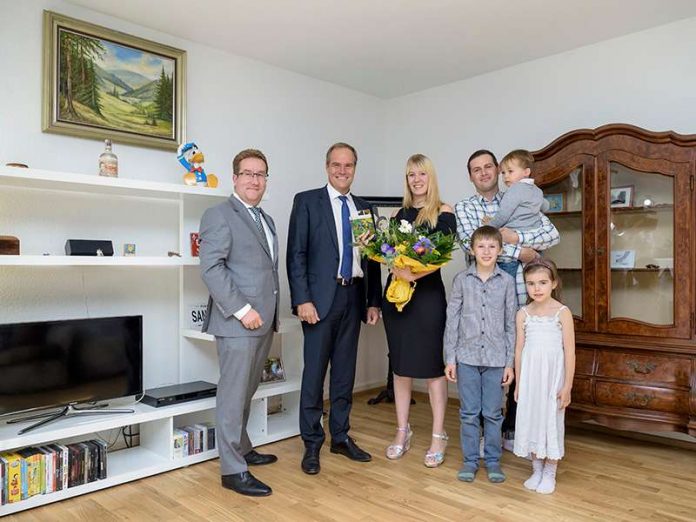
[43, 11, 186, 150]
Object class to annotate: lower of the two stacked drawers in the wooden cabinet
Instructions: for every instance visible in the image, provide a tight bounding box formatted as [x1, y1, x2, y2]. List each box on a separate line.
[595, 382, 689, 415]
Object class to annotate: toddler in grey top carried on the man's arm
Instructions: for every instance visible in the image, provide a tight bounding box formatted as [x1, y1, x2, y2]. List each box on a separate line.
[485, 149, 549, 277]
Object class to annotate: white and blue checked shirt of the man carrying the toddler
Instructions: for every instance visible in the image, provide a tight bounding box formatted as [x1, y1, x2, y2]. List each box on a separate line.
[454, 192, 561, 306]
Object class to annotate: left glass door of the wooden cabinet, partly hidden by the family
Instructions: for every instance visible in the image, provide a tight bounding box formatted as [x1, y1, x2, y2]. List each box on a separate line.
[537, 156, 595, 331]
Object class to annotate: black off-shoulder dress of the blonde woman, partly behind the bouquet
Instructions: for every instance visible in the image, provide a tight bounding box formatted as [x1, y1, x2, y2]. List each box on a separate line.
[382, 208, 457, 379]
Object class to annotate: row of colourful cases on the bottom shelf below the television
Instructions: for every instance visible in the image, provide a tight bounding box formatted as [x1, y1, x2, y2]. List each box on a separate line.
[0, 439, 107, 504]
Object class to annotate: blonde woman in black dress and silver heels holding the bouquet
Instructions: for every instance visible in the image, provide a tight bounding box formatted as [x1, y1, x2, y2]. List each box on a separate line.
[382, 154, 456, 468]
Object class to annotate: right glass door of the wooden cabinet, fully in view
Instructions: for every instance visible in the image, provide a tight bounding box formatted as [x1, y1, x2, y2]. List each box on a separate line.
[597, 151, 691, 337]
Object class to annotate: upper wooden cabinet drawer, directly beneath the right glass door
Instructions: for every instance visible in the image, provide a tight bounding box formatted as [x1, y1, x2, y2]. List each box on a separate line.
[597, 350, 691, 386]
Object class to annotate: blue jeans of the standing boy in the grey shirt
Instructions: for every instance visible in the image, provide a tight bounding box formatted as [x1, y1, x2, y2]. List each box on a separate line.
[457, 363, 505, 469]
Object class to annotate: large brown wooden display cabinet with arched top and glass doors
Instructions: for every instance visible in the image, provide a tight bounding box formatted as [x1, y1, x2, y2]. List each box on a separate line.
[533, 124, 696, 436]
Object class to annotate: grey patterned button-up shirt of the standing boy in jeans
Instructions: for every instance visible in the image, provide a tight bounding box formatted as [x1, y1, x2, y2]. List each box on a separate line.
[443, 264, 517, 368]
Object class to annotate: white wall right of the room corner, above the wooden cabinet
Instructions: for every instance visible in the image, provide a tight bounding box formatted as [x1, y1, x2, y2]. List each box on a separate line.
[385, 13, 696, 199]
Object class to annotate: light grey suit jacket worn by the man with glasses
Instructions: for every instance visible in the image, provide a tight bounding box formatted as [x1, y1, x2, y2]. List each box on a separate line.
[199, 195, 280, 337]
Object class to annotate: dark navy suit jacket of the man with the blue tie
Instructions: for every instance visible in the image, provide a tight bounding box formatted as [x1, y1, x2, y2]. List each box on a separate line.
[287, 187, 382, 321]
